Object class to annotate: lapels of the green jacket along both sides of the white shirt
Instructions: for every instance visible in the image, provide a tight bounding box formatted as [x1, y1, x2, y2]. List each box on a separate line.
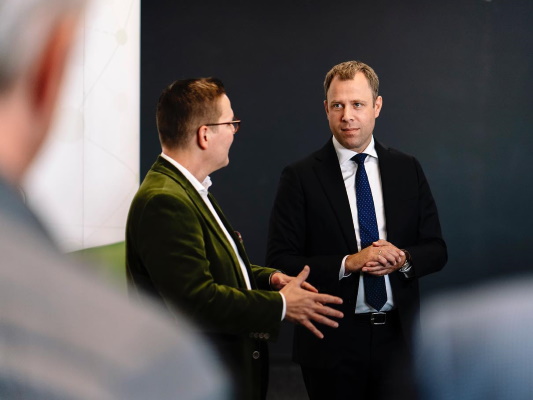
[152, 157, 256, 289]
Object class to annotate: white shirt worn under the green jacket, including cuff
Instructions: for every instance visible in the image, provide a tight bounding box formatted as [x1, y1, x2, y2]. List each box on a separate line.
[161, 153, 287, 320]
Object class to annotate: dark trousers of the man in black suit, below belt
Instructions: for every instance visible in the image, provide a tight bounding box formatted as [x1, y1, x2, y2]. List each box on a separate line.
[302, 311, 416, 400]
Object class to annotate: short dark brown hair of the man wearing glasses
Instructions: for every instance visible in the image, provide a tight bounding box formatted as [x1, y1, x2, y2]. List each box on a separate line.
[156, 78, 226, 148]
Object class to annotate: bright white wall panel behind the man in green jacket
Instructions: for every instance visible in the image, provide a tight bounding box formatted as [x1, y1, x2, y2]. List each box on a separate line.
[24, 0, 140, 251]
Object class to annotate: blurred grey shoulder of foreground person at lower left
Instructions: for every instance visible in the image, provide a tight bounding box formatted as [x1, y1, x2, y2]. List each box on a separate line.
[0, 213, 228, 399]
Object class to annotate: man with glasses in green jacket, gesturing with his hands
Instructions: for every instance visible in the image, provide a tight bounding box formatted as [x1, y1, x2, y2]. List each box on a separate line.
[126, 78, 342, 399]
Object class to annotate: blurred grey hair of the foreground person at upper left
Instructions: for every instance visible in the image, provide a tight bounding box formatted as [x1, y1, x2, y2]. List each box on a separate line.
[0, 0, 86, 92]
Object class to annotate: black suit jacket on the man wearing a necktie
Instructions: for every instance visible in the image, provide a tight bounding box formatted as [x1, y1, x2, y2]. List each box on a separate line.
[267, 140, 447, 367]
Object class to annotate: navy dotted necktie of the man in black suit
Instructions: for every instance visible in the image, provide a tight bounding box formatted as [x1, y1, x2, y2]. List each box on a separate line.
[352, 153, 387, 311]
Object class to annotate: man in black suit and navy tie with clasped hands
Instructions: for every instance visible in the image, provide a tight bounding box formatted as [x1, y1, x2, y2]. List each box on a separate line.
[267, 61, 447, 399]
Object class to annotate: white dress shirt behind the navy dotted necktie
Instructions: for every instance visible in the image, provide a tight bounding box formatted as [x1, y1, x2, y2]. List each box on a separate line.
[333, 136, 394, 314]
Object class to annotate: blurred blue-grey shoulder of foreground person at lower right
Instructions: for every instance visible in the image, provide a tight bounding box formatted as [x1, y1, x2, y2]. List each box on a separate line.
[416, 275, 533, 400]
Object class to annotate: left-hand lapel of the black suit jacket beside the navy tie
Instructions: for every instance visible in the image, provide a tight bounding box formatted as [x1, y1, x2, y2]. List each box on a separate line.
[313, 139, 357, 253]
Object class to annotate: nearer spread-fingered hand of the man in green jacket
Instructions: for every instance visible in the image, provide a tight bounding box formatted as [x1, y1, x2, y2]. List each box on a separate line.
[280, 265, 344, 339]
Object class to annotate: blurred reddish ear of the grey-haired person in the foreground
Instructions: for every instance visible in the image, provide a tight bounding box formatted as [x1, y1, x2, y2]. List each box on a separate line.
[29, 15, 78, 125]
